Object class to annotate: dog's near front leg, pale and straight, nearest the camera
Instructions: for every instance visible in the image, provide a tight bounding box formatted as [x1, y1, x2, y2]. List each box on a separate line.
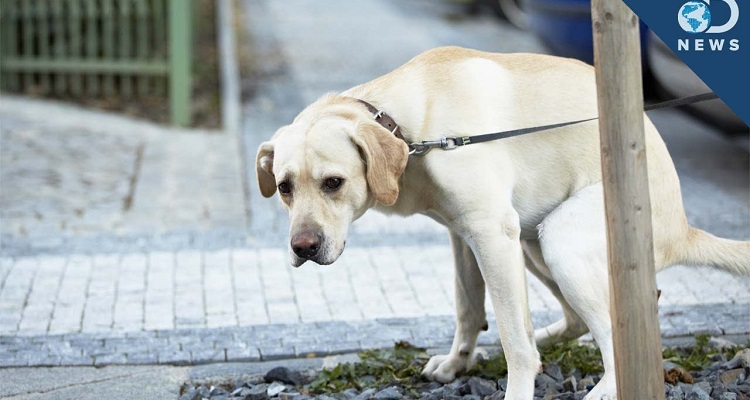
[457, 211, 541, 400]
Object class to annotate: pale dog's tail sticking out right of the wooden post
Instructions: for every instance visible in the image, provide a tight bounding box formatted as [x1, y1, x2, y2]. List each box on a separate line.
[679, 227, 750, 275]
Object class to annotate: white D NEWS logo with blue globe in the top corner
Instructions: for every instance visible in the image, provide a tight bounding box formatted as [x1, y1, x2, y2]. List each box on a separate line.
[677, 0, 740, 51]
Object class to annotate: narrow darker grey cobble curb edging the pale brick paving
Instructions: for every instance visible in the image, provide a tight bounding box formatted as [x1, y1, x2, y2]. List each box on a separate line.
[0, 303, 750, 367]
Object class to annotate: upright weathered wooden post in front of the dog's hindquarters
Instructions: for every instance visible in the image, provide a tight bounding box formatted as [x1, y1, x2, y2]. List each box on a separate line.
[592, 0, 664, 400]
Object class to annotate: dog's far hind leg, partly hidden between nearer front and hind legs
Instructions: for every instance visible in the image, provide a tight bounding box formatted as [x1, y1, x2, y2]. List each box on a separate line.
[523, 240, 588, 348]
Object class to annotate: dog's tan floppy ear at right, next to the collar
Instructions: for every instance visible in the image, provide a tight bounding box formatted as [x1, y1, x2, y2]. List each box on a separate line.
[352, 121, 409, 206]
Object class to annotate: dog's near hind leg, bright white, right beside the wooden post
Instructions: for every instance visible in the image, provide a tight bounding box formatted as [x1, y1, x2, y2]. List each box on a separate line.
[539, 184, 617, 400]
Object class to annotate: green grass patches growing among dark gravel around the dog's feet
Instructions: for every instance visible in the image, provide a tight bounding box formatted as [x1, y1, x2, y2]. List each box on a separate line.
[304, 335, 750, 397]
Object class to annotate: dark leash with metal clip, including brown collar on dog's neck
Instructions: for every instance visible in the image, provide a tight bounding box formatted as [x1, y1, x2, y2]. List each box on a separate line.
[360, 92, 719, 156]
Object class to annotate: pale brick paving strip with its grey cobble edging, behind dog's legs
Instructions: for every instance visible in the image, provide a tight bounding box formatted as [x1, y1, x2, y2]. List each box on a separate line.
[0, 246, 750, 366]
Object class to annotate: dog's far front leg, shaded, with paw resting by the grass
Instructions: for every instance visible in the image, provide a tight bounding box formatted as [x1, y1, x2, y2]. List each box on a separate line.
[422, 232, 487, 383]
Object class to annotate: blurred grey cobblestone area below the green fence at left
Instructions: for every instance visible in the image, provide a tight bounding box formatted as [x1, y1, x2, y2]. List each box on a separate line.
[0, 94, 246, 254]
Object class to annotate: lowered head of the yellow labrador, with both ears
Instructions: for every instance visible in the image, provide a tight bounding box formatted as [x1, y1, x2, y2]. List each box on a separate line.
[256, 95, 408, 267]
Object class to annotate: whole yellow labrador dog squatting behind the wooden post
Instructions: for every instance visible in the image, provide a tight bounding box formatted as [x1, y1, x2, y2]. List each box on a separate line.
[257, 47, 750, 400]
